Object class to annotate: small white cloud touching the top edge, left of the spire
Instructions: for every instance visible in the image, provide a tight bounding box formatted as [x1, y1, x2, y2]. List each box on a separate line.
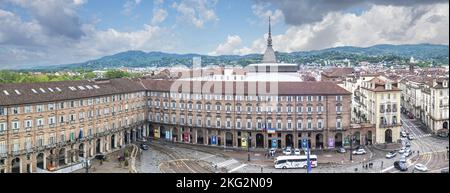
[172, 0, 219, 28]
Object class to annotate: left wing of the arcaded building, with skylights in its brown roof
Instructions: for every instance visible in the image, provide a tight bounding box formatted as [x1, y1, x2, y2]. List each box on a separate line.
[0, 79, 147, 173]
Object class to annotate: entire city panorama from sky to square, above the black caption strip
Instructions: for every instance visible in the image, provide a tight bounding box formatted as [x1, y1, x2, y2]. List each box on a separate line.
[0, 0, 449, 175]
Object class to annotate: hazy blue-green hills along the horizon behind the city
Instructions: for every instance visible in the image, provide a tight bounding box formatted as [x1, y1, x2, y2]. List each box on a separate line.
[33, 44, 449, 71]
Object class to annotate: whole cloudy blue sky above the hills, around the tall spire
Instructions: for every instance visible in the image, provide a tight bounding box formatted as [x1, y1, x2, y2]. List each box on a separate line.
[0, 0, 449, 69]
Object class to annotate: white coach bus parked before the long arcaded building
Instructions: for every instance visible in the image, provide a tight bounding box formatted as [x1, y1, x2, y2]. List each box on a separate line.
[274, 155, 317, 169]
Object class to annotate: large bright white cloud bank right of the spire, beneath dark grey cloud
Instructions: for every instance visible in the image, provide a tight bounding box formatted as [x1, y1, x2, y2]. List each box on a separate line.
[225, 3, 449, 53]
